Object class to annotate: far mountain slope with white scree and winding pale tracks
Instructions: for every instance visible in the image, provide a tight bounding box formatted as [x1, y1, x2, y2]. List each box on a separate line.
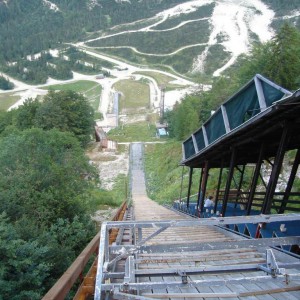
[82, 0, 300, 77]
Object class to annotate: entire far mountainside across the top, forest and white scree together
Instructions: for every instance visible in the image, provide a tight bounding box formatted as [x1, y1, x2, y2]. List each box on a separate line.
[0, 0, 300, 77]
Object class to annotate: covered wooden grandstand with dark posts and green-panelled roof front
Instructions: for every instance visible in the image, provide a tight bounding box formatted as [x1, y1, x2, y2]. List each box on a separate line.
[180, 75, 300, 216]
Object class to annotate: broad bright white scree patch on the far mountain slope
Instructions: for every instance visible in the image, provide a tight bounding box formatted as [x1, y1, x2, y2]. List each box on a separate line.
[193, 0, 275, 76]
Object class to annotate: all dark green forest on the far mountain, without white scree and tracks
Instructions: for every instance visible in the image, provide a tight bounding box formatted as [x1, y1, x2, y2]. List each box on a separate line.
[0, 0, 300, 82]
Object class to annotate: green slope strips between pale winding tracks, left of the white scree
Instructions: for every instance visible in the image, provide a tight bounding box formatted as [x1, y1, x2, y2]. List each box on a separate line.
[85, 4, 219, 76]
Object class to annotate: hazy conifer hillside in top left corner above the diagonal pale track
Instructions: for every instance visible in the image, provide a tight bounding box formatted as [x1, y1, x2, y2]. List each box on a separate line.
[0, 0, 189, 62]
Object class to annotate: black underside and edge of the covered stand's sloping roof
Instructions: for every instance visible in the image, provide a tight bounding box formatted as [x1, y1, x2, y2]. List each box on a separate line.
[181, 78, 300, 168]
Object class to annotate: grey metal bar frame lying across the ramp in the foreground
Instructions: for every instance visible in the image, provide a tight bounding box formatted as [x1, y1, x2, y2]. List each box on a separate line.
[94, 214, 300, 300]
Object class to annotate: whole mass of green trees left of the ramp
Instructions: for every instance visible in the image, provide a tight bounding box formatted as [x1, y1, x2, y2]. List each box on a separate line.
[0, 91, 99, 300]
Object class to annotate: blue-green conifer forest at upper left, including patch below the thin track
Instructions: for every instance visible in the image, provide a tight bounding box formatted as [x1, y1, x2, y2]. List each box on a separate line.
[0, 0, 188, 83]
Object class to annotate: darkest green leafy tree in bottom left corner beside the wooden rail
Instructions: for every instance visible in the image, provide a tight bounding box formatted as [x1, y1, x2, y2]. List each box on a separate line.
[0, 213, 51, 300]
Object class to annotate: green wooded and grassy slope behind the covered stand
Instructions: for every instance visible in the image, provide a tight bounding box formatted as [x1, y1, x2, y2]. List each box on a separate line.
[145, 24, 300, 203]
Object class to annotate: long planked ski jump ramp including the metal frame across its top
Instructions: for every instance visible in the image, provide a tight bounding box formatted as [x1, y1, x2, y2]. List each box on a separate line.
[95, 144, 300, 300]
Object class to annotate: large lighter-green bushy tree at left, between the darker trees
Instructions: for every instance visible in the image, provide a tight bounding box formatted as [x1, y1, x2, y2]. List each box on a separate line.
[0, 128, 96, 227]
